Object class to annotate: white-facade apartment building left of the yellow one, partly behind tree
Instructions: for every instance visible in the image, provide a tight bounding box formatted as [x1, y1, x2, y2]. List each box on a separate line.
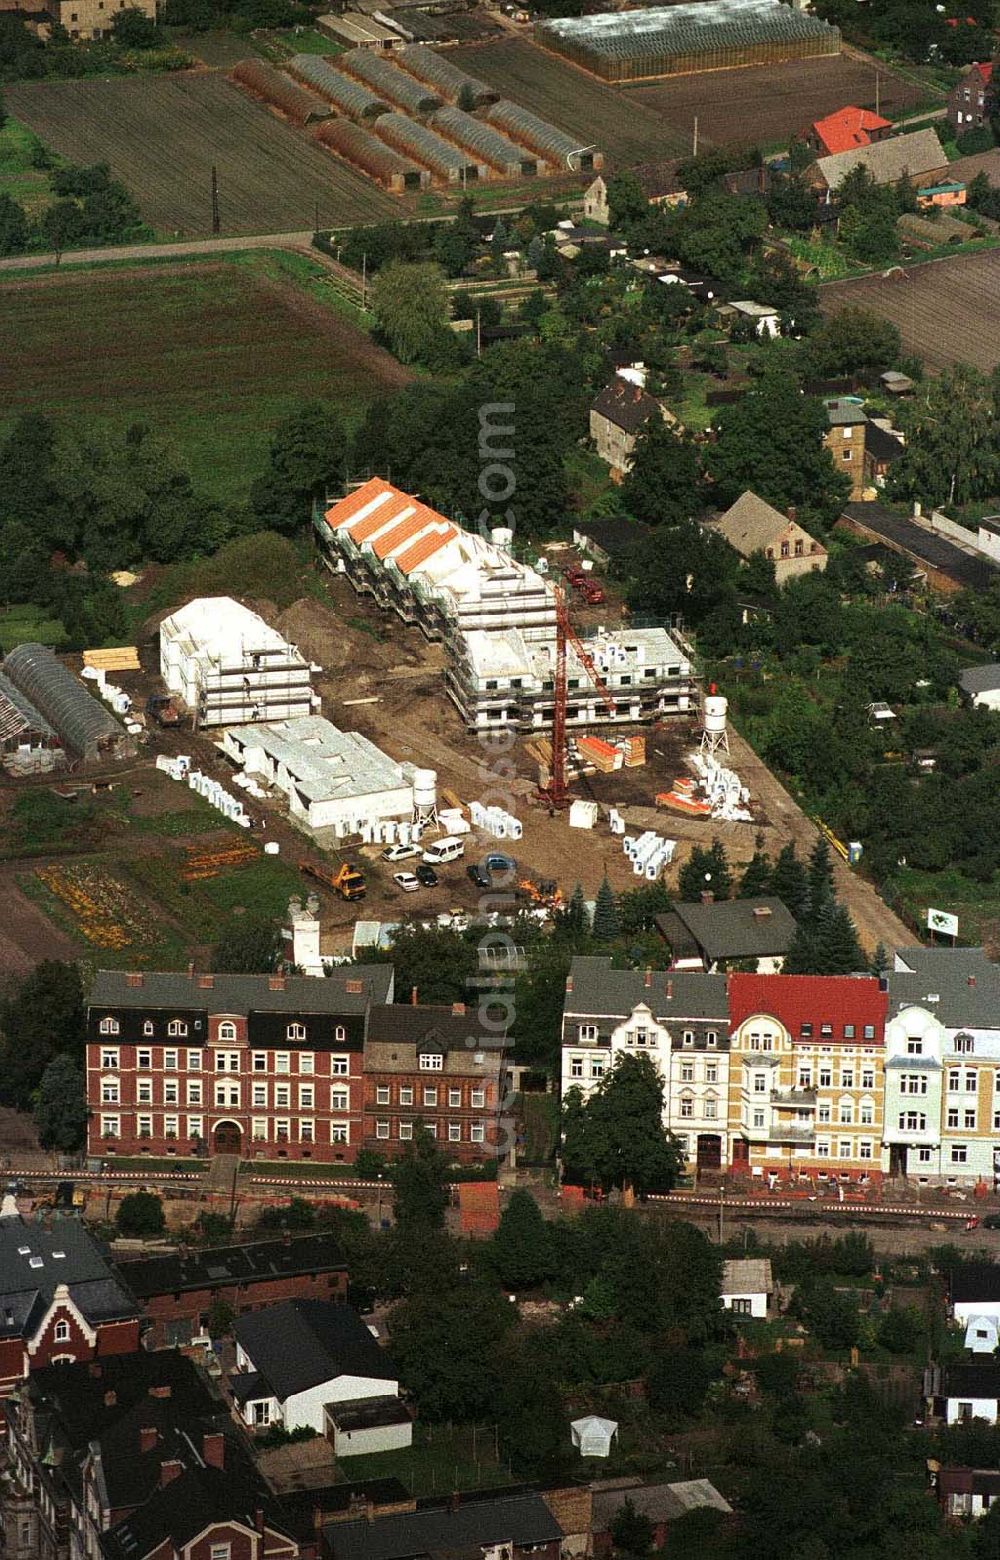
[562, 958, 729, 1170]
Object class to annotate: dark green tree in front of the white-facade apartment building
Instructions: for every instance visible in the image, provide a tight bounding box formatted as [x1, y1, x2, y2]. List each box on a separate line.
[563, 1055, 683, 1197]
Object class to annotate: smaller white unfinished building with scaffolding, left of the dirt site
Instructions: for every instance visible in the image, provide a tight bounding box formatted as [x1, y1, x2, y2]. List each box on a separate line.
[159, 596, 320, 725]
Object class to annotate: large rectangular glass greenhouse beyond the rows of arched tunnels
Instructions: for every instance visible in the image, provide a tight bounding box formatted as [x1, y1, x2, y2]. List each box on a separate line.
[535, 0, 841, 81]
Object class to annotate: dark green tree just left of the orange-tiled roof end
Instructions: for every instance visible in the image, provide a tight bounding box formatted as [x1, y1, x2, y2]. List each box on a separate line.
[250, 401, 348, 534]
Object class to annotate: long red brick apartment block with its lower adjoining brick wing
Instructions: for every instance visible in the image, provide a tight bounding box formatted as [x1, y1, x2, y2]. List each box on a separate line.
[87, 964, 504, 1164]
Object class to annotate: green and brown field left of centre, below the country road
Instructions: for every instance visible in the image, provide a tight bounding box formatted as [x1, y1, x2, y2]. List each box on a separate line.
[0, 251, 410, 499]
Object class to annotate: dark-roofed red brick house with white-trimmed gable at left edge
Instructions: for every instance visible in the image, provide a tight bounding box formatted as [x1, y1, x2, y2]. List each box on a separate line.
[0, 1214, 139, 1426]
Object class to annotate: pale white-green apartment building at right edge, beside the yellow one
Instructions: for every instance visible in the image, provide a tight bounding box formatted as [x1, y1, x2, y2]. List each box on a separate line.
[883, 947, 1000, 1189]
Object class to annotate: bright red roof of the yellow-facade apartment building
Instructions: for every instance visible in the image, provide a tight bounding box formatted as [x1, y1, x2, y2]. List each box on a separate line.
[729, 975, 889, 1045]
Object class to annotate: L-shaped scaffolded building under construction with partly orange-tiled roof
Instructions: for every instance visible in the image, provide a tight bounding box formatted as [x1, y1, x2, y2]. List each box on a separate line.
[315, 477, 694, 732]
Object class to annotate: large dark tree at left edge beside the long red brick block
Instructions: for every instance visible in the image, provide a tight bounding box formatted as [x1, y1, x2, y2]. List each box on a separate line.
[0, 959, 86, 1111]
